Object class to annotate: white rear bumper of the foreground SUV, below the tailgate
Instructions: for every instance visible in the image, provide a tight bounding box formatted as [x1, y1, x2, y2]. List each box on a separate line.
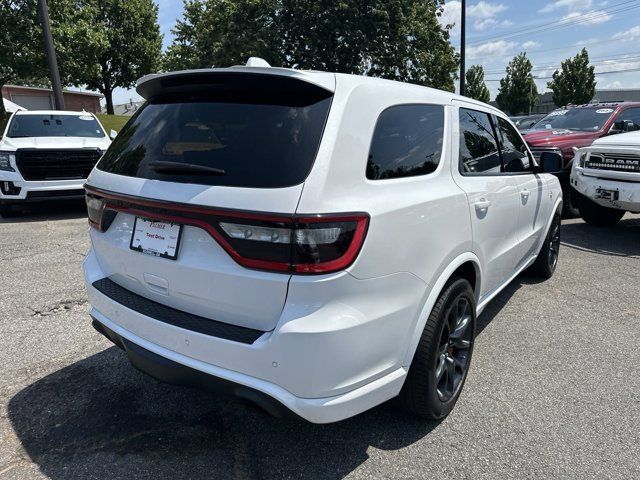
[84, 250, 428, 423]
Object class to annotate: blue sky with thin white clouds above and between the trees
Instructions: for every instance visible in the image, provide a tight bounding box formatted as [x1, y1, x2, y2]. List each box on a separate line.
[114, 0, 640, 103]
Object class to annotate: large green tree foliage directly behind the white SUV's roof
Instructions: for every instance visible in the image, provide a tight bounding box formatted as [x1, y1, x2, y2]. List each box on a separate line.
[164, 0, 458, 91]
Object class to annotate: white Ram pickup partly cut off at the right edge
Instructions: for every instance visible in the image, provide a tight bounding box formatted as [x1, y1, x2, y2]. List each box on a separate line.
[571, 131, 640, 226]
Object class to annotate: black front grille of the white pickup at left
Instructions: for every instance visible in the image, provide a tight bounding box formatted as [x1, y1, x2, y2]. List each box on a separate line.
[16, 148, 102, 180]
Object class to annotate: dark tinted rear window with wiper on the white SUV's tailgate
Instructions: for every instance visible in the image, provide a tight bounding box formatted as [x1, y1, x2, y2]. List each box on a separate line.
[97, 89, 331, 188]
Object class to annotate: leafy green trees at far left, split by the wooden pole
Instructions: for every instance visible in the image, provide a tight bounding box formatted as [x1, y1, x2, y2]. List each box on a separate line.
[0, 0, 162, 115]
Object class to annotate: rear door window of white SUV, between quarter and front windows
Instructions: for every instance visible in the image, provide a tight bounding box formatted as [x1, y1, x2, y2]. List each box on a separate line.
[460, 108, 501, 174]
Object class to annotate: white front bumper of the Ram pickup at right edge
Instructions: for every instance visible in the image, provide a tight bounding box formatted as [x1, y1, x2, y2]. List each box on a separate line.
[571, 167, 640, 213]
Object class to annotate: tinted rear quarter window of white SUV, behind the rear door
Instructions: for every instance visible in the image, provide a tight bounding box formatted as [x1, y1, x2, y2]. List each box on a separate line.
[367, 105, 444, 180]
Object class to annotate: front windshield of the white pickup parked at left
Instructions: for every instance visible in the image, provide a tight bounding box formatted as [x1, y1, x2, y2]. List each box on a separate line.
[7, 114, 105, 138]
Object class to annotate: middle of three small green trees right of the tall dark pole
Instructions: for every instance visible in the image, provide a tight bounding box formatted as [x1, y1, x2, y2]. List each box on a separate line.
[496, 52, 538, 115]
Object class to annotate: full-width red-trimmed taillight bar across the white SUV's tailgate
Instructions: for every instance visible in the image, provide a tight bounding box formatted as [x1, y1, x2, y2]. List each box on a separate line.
[85, 186, 369, 274]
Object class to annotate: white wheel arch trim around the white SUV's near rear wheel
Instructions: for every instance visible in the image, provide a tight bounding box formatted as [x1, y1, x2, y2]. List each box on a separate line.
[402, 252, 482, 368]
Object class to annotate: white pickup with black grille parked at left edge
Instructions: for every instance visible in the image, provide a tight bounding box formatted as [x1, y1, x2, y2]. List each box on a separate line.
[0, 110, 115, 217]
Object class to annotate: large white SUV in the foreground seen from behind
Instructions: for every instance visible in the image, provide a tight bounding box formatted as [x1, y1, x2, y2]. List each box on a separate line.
[84, 61, 562, 423]
